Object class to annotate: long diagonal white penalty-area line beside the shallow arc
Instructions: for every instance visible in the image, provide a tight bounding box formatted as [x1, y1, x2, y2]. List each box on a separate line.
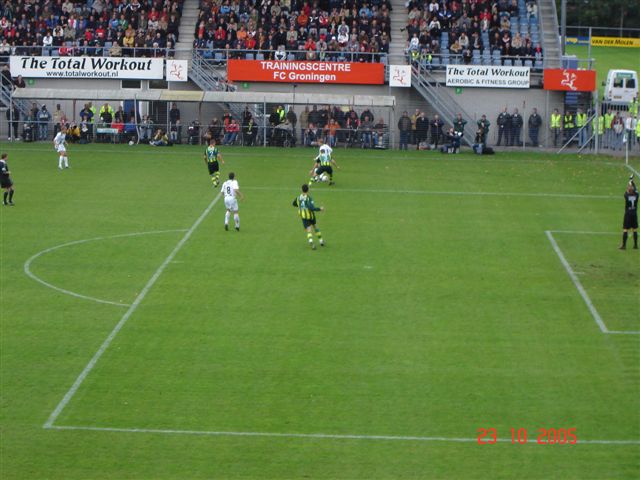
[44, 193, 221, 428]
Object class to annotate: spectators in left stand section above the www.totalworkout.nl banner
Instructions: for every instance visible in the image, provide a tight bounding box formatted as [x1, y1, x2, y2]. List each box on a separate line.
[0, 0, 183, 58]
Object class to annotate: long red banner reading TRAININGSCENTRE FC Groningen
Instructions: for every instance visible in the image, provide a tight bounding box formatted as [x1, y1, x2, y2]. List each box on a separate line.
[227, 60, 384, 85]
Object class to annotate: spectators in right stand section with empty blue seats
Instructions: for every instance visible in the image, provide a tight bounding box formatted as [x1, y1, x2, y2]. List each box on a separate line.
[405, 0, 543, 66]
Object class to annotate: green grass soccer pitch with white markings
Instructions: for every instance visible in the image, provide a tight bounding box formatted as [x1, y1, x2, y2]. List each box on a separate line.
[0, 144, 640, 480]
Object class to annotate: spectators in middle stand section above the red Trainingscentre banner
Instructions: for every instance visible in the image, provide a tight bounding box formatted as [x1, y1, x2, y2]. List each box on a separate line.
[194, 0, 391, 62]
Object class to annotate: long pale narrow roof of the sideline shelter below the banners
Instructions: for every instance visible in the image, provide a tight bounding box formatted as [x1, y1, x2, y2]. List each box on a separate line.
[13, 88, 396, 107]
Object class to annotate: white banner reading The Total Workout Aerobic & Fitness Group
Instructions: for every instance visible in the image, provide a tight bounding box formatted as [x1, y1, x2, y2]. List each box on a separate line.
[447, 65, 531, 88]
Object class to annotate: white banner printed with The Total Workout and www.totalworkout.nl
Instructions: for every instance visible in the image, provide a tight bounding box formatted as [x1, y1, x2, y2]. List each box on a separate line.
[10, 55, 164, 80]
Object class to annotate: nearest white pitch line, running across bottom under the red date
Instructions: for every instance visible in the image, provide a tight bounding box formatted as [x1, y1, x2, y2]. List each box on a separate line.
[48, 425, 640, 445]
